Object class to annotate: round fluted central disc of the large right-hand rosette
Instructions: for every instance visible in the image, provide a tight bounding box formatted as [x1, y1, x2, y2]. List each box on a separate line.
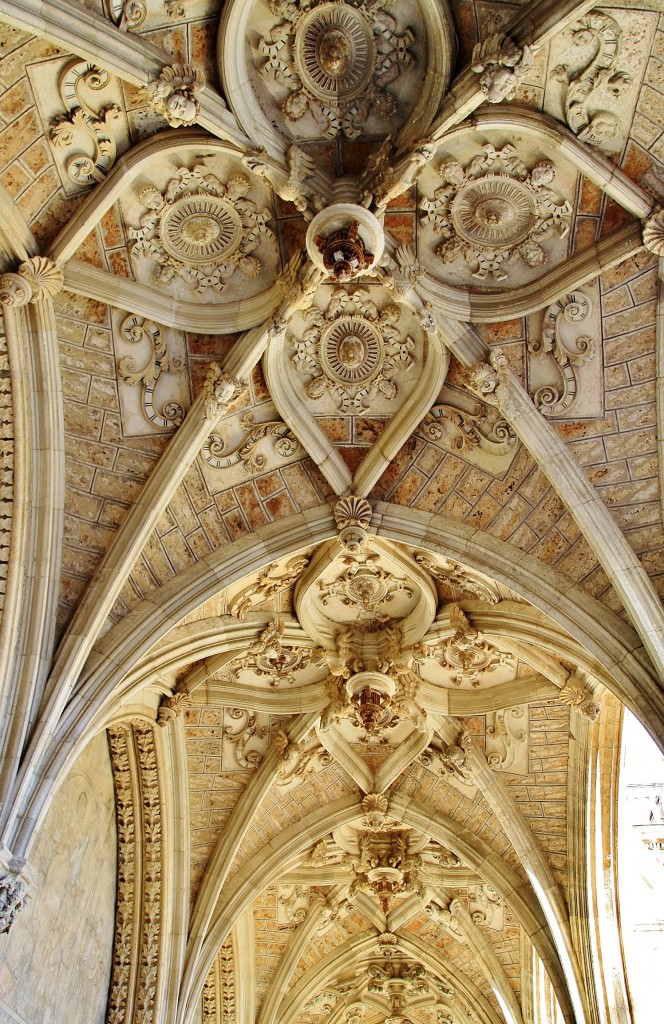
[450, 174, 537, 249]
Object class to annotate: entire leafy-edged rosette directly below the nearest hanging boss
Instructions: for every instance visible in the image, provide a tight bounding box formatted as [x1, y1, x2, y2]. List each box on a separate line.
[291, 288, 415, 413]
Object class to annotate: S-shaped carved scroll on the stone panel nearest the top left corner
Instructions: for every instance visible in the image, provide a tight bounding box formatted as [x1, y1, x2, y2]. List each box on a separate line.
[50, 60, 121, 185]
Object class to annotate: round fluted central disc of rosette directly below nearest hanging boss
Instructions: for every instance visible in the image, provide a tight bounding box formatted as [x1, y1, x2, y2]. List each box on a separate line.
[321, 316, 383, 385]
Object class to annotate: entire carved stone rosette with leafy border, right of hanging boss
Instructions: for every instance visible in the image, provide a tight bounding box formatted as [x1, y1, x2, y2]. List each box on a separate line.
[420, 144, 572, 281]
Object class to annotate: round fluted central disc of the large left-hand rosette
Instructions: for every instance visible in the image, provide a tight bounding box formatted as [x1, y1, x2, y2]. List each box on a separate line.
[160, 196, 242, 263]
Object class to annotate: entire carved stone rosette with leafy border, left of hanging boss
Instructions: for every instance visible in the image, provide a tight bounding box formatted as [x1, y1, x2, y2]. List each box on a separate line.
[129, 165, 275, 295]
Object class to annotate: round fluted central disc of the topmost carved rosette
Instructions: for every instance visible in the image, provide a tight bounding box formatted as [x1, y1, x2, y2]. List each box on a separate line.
[295, 3, 375, 104]
